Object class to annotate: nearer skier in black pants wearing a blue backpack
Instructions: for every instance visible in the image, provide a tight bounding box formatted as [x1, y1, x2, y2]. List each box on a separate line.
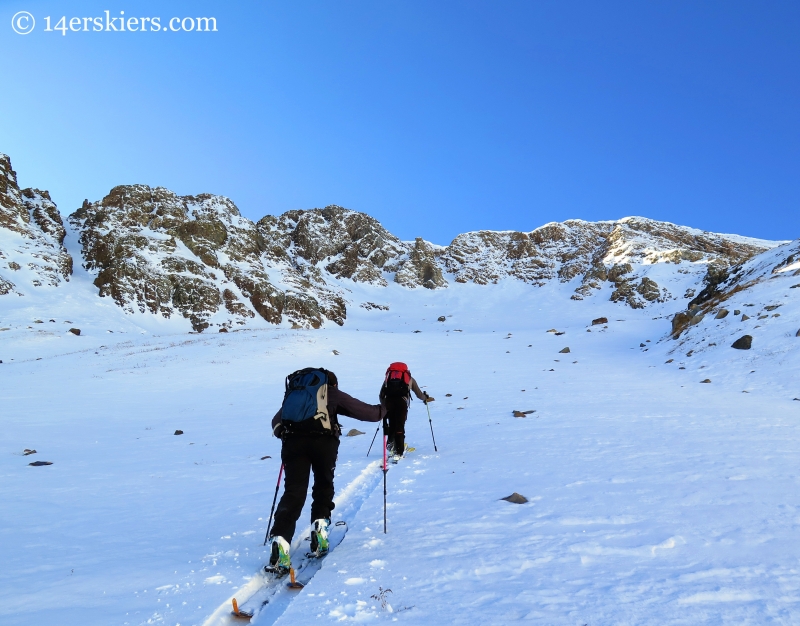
[269, 368, 386, 574]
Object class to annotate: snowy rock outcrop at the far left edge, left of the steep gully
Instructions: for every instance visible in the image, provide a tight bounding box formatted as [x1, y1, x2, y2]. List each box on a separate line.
[0, 154, 72, 296]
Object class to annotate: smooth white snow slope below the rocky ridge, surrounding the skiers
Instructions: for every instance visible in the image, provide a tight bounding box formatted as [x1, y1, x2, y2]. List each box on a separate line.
[0, 270, 800, 626]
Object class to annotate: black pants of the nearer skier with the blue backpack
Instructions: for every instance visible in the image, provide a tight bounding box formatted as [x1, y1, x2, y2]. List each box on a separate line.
[269, 434, 339, 543]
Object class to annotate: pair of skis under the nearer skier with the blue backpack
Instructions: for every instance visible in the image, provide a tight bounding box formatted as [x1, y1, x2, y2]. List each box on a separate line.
[231, 520, 347, 620]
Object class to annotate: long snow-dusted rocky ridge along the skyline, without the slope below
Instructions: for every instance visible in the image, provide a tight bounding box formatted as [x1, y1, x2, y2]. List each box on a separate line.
[0, 155, 778, 331]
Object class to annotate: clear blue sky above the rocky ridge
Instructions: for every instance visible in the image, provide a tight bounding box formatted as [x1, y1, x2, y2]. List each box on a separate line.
[0, 0, 800, 244]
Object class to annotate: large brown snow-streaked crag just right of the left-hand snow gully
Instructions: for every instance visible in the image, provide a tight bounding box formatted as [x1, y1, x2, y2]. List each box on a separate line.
[70, 185, 346, 331]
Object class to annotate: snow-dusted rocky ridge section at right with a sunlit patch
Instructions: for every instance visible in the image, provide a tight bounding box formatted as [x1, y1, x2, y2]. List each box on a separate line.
[439, 217, 770, 308]
